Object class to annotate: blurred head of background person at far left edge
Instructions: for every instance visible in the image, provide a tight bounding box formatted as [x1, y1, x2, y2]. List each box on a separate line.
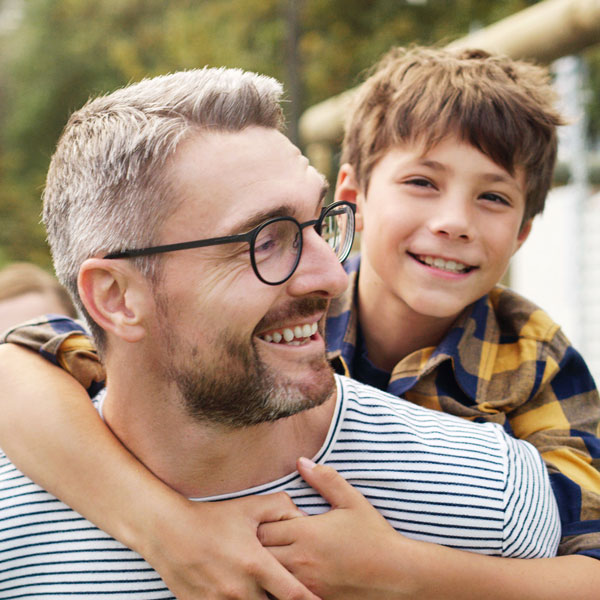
[0, 262, 77, 332]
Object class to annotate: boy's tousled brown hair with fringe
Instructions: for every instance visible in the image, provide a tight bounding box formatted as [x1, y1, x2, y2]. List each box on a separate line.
[341, 47, 564, 222]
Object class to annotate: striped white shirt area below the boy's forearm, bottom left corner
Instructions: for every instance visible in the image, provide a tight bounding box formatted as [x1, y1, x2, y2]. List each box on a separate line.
[0, 449, 166, 600]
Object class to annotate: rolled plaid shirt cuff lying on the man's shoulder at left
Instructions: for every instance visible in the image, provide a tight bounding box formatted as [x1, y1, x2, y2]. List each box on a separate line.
[0, 315, 106, 396]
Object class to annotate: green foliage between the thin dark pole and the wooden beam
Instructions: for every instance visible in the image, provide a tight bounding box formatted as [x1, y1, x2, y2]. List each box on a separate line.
[301, 0, 535, 106]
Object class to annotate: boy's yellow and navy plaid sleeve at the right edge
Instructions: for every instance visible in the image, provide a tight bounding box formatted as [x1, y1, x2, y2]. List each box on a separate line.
[507, 340, 600, 559]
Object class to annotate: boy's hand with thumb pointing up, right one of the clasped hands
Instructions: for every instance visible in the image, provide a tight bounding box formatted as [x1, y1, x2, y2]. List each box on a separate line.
[258, 459, 416, 600]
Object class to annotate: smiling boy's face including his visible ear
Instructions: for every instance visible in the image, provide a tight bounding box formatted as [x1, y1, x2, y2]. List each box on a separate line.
[336, 136, 531, 321]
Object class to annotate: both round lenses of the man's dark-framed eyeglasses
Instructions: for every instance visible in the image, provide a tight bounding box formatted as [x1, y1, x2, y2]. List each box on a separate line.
[252, 205, 354, 284]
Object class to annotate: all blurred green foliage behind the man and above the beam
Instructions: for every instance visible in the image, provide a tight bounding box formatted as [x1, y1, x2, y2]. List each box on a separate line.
[0, 0, 600, 266]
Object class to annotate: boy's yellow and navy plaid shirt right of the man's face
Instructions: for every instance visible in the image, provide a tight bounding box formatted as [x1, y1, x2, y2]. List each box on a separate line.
[327, 257, 600, 559]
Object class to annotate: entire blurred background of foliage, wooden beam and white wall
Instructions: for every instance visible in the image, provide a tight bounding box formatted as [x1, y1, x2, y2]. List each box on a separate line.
[0, 0, 600, 379]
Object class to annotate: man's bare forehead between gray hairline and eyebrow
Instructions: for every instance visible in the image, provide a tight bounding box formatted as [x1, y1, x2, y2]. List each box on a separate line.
[163, 127, 327, 235]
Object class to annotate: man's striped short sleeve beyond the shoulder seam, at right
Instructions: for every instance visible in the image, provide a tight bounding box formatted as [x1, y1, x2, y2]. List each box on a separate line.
[502, 428, 561, 558]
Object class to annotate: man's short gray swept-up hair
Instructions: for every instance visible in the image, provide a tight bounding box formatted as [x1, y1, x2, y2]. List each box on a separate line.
[43, 68, 283, 345]
